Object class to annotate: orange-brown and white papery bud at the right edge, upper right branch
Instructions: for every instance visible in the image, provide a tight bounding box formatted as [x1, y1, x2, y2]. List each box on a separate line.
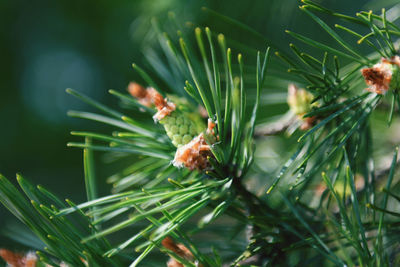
[361, 56, 400, 95]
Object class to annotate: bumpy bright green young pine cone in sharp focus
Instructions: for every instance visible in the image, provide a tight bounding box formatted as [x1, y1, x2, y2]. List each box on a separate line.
[160, 110, 199, 147]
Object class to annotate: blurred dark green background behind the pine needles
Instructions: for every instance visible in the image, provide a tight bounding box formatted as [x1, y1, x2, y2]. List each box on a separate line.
[0, 0, 394, 253]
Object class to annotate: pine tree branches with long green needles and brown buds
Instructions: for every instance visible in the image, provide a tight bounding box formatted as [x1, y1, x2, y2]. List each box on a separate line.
[0, 0, 400, 266]
